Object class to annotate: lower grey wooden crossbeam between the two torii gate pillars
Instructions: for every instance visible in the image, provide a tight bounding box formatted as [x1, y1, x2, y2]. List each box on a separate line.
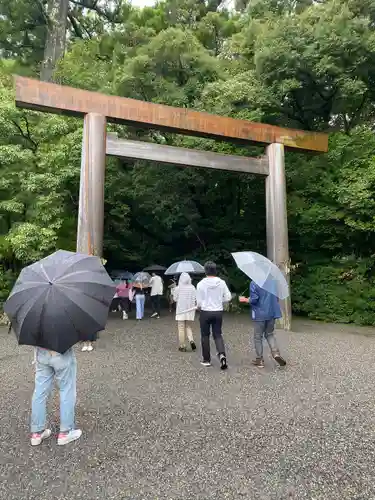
[106, 134, 268, 175]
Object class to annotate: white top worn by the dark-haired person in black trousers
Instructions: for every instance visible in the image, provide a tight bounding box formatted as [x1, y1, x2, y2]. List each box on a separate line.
[197, 277, 232, 312]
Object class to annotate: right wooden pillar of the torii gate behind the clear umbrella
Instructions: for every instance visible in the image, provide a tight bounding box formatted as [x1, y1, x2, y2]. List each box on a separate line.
[266, 144, 292, 330]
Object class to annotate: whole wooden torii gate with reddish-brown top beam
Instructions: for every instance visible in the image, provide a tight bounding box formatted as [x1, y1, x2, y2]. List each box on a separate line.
[15, 76, 328, 330]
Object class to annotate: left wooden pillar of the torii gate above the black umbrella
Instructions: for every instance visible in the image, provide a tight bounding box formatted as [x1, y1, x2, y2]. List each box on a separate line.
[77, 113, 106, 257]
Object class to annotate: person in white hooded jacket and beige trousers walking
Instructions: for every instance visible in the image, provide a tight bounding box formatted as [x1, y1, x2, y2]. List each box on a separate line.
[173, 273, 197, 352]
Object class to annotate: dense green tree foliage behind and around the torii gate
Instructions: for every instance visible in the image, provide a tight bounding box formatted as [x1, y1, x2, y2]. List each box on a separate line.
[0, 0, 375, 324]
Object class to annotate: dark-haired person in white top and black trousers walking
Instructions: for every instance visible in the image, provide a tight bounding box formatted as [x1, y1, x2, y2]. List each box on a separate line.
[197, 262, 232, 370]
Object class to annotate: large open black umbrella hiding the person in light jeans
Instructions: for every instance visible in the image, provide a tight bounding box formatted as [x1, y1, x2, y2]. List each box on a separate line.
[4, 250, 115, 354]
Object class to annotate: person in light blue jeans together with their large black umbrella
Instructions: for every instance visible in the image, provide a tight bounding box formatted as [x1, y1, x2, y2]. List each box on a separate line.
[4, 250, 115, 446]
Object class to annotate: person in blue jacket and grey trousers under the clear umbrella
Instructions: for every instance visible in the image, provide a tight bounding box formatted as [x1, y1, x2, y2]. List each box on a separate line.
[240, 281, 286, 368]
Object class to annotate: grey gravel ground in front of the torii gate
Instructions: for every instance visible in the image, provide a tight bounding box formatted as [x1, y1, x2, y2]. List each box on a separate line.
[0, 316, 375, 500]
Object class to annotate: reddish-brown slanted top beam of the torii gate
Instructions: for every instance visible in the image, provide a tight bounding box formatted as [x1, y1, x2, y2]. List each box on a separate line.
[16, 76, 328, 152]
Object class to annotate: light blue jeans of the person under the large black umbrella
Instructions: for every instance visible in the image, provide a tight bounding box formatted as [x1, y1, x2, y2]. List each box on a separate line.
[31, 348, 77, 433]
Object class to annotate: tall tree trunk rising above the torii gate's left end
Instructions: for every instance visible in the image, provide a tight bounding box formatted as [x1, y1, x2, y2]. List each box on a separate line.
[40, 0, 69, 82]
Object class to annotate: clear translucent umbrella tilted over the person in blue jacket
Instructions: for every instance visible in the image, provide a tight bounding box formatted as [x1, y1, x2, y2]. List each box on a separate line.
[232, 252, 289, 299]
